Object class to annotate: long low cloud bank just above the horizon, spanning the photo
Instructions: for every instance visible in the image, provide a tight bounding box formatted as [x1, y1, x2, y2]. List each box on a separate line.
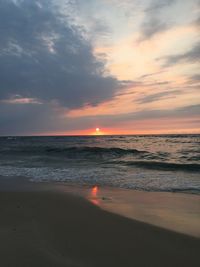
[0, 100, 200, 135]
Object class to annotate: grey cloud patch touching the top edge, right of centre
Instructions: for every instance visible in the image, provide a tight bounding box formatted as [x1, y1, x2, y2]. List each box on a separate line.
[140, 0, 176, 41]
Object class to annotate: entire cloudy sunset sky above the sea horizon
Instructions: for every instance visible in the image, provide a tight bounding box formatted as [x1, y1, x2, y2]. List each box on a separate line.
[0, 0, 200, 135]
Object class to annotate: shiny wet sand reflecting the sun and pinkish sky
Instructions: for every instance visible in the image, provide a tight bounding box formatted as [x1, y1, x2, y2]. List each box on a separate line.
[87, 187, 200, 238]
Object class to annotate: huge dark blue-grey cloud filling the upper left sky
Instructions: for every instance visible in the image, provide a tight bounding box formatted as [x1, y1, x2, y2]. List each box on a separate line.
[0, 0, 121, 108]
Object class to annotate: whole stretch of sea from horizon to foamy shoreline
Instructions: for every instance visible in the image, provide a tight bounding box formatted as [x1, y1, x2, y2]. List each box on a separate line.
[0, 135, 200, 194]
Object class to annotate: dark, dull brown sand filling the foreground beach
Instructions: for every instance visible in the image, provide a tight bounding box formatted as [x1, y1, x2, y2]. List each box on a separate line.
[0, 189, 200, 267]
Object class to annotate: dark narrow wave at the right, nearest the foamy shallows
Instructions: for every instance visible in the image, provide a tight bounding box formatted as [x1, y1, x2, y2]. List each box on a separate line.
[115, 161, 200, 172]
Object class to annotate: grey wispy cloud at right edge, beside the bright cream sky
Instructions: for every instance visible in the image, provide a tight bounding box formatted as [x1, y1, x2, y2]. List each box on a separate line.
[158, 43, 200, 67]
